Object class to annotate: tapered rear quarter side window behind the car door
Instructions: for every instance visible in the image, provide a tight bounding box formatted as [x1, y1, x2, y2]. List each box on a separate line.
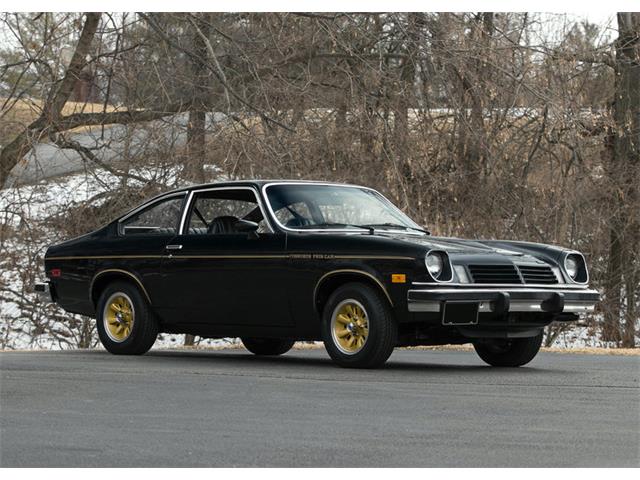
[121, 195, 184, 235]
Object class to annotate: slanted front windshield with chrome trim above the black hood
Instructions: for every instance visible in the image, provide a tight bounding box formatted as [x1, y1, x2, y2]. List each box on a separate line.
[266, 184, 422, 231]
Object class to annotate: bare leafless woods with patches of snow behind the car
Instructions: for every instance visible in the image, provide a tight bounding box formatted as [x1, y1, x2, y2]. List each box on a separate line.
[0, 12, 640, 348]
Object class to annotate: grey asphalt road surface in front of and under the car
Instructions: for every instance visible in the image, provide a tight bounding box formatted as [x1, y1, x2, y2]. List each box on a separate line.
[0, 350, 640, 467]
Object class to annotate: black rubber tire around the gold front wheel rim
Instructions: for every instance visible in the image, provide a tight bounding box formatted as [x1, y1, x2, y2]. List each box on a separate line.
[322, 283, 398, 368]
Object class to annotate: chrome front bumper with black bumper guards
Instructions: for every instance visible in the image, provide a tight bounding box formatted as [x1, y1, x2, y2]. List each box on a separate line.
[407, 286, 600, 314]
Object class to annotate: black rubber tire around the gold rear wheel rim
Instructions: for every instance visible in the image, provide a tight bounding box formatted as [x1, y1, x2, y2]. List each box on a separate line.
[96, 281, 158, 355]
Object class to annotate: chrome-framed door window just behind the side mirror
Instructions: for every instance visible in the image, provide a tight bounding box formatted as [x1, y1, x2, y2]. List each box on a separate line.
[185, 189, 269, 235]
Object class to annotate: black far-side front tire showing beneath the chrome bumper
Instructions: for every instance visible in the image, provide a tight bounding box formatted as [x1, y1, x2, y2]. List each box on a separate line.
[473, 331, 542, 367]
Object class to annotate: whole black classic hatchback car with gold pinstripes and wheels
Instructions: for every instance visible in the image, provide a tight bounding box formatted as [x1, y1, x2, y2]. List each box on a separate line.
[37, 181, 599, 368]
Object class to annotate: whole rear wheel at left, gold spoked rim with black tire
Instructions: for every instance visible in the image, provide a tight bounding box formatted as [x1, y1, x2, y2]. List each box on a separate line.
[97, 281, 158, 355]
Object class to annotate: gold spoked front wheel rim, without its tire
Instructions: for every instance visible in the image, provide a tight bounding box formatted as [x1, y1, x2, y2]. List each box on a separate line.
[331, 298, 369, 355]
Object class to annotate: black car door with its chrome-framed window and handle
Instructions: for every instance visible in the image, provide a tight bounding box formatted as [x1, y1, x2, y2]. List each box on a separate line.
[158, 187, 292, 327]
